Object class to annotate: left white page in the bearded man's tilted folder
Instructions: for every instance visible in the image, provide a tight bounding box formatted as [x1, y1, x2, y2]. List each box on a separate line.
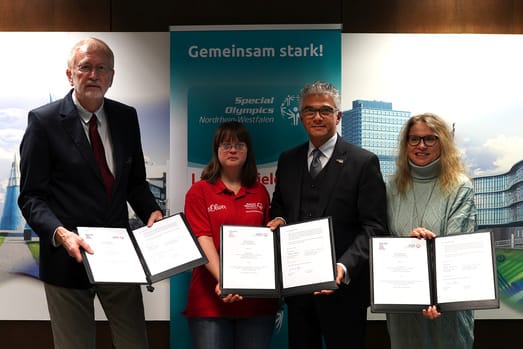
[78, 227, 147, 283]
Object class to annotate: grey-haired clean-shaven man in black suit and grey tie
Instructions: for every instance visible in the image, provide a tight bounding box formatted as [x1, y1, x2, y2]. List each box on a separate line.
[268, 81, 388, 349]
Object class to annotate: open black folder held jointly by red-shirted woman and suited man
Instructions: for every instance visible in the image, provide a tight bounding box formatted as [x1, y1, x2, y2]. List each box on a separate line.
[220, 217, 337, 298]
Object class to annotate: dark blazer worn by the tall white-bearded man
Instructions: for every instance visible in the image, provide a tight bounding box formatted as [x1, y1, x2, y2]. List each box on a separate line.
[18, 91, 160, 288]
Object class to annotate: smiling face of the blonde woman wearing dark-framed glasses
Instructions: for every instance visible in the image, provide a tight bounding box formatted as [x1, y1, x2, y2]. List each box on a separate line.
[407, 122, 441, 166]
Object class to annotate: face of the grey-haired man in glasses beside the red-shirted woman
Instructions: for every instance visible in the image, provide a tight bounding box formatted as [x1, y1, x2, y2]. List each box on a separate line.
[300, 94, 341, 147]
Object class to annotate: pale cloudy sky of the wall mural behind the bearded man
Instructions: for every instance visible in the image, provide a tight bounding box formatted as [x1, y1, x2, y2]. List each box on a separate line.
[0, 32, 169, 214]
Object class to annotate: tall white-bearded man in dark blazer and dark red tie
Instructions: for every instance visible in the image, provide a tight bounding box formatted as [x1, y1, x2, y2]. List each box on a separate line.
[18, 38, 162, 349]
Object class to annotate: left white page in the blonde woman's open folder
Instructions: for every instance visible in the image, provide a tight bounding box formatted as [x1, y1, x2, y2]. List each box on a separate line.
[372, 237, 431, 304]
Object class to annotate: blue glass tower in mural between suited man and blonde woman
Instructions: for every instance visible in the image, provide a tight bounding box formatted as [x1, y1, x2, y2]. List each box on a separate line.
[341, 100, 410, 178]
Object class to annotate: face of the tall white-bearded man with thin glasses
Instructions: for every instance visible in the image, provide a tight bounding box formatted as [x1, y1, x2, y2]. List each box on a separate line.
[66, 43, 114, 112]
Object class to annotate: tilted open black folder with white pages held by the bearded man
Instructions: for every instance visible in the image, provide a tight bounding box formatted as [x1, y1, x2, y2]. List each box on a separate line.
[78, 213, 207, 285]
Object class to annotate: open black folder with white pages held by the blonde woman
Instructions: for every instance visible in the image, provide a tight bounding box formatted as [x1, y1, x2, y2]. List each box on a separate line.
[370, 231, 499, 313]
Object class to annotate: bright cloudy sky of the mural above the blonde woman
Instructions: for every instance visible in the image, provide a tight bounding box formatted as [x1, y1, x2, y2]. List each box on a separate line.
[342, 34, 523, 177]
